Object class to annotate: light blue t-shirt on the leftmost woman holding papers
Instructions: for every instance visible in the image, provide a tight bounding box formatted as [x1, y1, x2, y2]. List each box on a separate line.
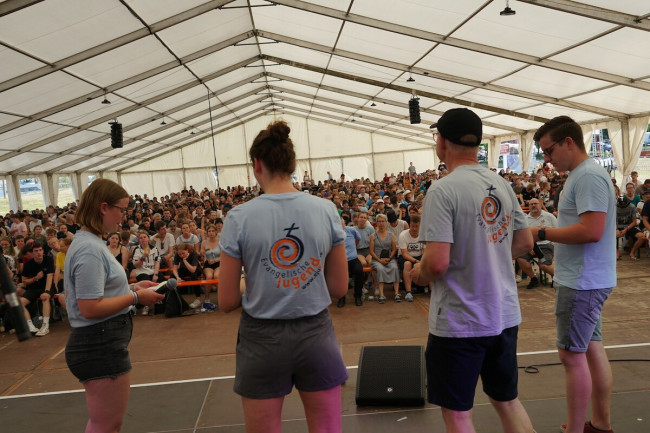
[64, 230, 130, 328]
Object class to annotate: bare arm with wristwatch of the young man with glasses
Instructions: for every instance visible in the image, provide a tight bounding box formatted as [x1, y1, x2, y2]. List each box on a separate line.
[530, 211, 607, 245]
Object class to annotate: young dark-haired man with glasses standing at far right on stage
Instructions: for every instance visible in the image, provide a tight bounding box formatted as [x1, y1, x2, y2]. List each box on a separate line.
[531, 116, 616, 433]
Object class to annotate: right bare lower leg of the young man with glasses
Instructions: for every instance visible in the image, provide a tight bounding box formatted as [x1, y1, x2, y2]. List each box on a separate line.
[587, 341, 612, 430]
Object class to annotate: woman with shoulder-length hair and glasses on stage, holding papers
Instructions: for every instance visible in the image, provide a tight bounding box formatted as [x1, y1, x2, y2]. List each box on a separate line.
[64, 179, 164, 432]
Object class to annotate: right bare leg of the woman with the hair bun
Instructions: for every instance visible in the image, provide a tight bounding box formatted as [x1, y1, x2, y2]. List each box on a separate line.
[300, 386, 341, 433]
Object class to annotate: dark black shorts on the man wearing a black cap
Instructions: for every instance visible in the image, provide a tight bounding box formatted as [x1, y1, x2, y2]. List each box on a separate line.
[426, 326, 519, 411]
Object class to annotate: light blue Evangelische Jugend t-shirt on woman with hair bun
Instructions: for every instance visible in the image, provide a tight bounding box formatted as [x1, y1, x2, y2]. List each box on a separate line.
[219, 192, 347, 319]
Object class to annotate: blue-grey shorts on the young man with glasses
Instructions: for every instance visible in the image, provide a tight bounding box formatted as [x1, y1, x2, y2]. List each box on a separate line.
[555, 283, 612, 353]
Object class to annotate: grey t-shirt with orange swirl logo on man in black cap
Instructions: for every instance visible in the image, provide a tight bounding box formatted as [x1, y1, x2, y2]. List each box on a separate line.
[420, 165, 528, 338]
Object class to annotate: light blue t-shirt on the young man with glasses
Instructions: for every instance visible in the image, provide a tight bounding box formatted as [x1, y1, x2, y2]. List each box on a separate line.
[553, 159, 616, 290]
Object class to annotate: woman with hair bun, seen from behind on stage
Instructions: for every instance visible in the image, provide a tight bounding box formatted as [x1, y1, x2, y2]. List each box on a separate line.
[218, 121, 348, 433]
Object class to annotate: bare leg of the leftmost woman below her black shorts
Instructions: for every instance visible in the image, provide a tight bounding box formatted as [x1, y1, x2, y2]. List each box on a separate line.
[84, 372, 131, 433]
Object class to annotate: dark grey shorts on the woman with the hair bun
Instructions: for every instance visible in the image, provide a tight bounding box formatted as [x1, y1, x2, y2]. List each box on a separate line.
[233, 309, 348, 399]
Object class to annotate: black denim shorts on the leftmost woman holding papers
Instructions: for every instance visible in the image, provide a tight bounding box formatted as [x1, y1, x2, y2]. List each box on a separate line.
[65, 313, 133, 383]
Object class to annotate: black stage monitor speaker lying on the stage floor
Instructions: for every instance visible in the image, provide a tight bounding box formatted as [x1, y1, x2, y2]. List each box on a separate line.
[355, 346, 426, 406]
